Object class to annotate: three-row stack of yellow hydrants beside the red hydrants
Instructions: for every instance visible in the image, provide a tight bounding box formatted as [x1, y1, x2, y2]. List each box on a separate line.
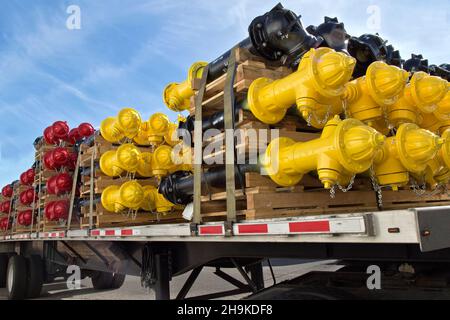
[96, 108, 190, 213]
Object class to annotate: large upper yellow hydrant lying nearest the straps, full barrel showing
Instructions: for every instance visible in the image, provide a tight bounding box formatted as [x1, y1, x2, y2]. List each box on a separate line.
[247, 48, 356, 129]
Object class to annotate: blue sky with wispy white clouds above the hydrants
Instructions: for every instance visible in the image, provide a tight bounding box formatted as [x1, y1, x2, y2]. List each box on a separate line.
[0, 0, 450, 187]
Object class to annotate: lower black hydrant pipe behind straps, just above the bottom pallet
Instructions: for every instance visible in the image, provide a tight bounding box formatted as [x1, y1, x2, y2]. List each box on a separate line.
[158, 164, 260, 205]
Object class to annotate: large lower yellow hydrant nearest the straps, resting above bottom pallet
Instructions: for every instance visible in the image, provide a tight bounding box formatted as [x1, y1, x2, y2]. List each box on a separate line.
[261, 116, 386, 189]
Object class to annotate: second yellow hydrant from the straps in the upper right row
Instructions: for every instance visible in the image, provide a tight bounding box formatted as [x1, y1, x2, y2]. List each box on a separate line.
[343, 61, 409, 126]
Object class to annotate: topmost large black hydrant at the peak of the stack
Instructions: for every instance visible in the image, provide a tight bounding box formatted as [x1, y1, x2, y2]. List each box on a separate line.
[208, 3, 323, 82]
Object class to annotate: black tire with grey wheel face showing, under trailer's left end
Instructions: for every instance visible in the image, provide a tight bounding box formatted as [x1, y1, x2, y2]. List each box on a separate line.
[6, 256, 28, 300]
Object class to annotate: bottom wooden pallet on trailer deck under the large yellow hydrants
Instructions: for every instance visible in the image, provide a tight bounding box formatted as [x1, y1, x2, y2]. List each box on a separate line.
[202, 173, 450, 221]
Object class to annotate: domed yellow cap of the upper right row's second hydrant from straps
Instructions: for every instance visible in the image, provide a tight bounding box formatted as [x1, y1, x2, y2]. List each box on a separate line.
[366, 61, 409, 105]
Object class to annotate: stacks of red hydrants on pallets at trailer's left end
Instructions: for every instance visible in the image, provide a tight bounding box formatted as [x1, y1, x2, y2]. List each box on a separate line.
[0, 121, 95, 231]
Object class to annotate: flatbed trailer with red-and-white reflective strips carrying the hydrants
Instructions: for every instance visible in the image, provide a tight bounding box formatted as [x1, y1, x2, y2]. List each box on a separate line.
[0, 206, 450, 299]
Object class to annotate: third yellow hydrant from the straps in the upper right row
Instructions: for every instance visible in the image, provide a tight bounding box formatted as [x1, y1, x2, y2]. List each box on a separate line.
[387, 72, 448, 128]
